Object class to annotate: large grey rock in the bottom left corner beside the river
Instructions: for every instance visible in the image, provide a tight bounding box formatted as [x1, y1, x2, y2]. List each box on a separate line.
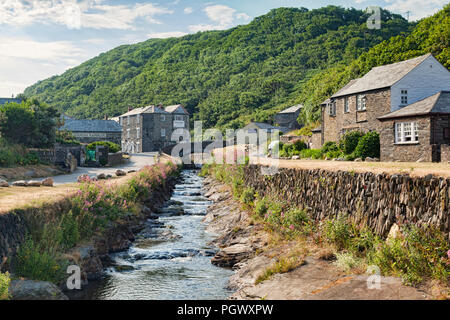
[9, 280, 69, 300]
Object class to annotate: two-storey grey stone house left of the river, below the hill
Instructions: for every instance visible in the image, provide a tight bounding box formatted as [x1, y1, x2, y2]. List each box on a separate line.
[119, 105, 189, 153]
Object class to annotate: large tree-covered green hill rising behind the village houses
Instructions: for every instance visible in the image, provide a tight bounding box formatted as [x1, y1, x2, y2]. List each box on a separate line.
[25, 6, 413, 128]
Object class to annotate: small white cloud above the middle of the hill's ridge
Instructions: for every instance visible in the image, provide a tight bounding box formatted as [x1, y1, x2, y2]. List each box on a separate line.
[189, 4, 250, 32]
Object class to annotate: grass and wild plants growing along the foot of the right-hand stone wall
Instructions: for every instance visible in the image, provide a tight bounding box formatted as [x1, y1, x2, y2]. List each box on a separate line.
[203, 165, 450, 286]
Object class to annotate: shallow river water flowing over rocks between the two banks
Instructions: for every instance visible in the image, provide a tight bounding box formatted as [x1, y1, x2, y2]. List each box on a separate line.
[71, 170, 232, 300]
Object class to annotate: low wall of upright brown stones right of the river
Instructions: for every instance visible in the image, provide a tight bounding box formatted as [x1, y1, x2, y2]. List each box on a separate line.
[244, 165, 450, 240]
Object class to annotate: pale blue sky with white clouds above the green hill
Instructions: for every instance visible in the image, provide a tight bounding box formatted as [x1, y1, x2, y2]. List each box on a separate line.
[0, 0, 448, 97]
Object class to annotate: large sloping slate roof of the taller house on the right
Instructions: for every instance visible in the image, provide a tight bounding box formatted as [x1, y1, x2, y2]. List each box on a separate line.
[331, 53, 432, 98]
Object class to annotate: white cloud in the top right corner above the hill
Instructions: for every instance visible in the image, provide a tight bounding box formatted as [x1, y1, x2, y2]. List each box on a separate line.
[385, 0, 448, 20]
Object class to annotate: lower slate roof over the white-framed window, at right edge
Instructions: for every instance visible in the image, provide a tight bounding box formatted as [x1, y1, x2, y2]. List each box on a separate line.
[378, 91, 450, 120]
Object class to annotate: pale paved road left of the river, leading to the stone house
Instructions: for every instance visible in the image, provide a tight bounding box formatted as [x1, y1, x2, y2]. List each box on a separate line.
[34, 152, 158, 185]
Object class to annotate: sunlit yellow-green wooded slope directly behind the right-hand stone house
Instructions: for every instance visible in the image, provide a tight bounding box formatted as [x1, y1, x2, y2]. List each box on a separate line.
[294, 4, 450, 122]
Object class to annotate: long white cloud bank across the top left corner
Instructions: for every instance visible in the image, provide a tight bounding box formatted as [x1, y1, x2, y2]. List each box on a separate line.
[0, 0, 172, 30]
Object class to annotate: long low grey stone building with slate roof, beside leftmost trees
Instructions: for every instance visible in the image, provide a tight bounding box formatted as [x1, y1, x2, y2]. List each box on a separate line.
[59, 117, 122, 145]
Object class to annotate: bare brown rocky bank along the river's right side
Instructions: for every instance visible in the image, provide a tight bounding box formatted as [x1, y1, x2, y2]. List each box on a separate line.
[204, 178, 431, 300]
